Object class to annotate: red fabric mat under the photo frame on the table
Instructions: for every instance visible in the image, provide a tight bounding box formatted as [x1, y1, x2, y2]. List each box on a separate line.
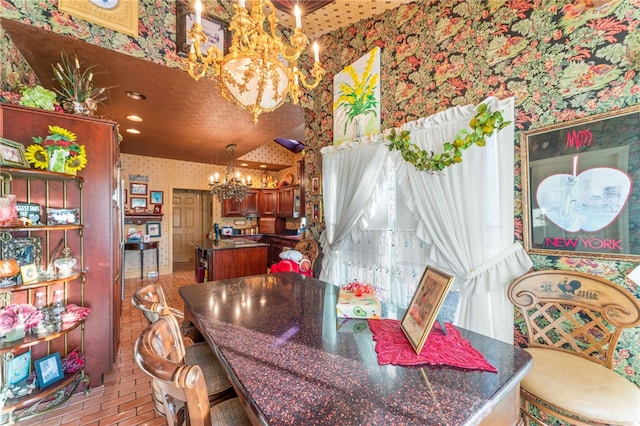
[369, 319, 498, 373]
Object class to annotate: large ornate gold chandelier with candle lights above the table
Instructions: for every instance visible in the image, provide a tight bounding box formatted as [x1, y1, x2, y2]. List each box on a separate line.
[186, 0, 325, 123]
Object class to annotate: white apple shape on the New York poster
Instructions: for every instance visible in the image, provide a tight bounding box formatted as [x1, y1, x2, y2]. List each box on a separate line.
[536, 167, 633, 232]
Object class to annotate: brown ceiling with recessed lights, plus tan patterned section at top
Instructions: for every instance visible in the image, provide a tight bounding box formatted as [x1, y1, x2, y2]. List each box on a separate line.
[0, 0, 408, 170]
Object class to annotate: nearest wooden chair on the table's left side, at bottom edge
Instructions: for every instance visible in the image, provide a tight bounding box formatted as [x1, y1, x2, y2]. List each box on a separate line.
[134, 314, 251, 426]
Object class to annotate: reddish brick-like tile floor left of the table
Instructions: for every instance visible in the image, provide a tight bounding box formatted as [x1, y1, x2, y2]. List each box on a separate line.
[18, 262, 194, 426]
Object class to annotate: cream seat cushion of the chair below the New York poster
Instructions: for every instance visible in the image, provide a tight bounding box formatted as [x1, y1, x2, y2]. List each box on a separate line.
[521, 348, 640, 424]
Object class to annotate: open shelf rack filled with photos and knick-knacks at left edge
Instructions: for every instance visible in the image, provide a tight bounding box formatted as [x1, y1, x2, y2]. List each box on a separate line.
[0, 168, 89, 424]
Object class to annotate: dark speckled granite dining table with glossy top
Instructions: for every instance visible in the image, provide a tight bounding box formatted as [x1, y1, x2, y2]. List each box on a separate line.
[179, 272, 532, 426]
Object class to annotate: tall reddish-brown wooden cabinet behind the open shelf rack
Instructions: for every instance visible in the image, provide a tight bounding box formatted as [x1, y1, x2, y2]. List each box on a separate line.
[0, 104, 123, 387]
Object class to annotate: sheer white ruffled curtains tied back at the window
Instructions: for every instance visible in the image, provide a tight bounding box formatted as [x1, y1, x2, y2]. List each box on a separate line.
[321, 98, 531, 342]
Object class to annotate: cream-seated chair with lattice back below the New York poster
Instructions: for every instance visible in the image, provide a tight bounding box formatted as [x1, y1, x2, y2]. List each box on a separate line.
[508, 270, 640, 425]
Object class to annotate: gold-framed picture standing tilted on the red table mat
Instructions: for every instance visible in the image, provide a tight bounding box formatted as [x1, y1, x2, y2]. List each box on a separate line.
[400, 266, 453, 354]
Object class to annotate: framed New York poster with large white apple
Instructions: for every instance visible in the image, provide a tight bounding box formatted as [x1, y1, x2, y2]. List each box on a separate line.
[522, 107, 640, 260]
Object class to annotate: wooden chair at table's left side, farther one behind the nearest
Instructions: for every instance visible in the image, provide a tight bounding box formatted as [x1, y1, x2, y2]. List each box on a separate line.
[131, 283, 235, 414]
